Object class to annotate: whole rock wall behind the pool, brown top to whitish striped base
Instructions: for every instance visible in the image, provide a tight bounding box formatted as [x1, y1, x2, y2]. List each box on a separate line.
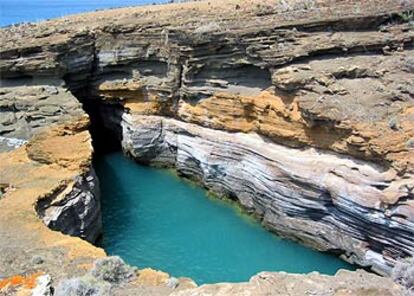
[0, 0, 414, 284]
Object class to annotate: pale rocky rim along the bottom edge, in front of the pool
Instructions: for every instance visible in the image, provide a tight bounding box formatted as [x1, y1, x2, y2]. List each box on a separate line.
[171, 270, 402, 296]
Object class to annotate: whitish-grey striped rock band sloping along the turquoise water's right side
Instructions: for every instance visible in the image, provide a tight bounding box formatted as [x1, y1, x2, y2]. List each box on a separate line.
[118, 114, 414, 273]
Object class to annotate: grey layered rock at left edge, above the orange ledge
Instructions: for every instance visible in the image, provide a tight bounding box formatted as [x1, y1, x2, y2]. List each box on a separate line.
[0, 78, 83, 152]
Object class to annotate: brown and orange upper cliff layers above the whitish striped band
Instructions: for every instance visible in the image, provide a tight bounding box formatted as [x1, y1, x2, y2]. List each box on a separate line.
[0, 1, 414, 174]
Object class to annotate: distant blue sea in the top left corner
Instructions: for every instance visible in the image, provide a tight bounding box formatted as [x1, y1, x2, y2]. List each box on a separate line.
[0, 0, 167, 27]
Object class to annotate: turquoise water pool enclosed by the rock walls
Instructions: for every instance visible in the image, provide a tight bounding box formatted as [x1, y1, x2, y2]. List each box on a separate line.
[96, 153, 353, 284]
